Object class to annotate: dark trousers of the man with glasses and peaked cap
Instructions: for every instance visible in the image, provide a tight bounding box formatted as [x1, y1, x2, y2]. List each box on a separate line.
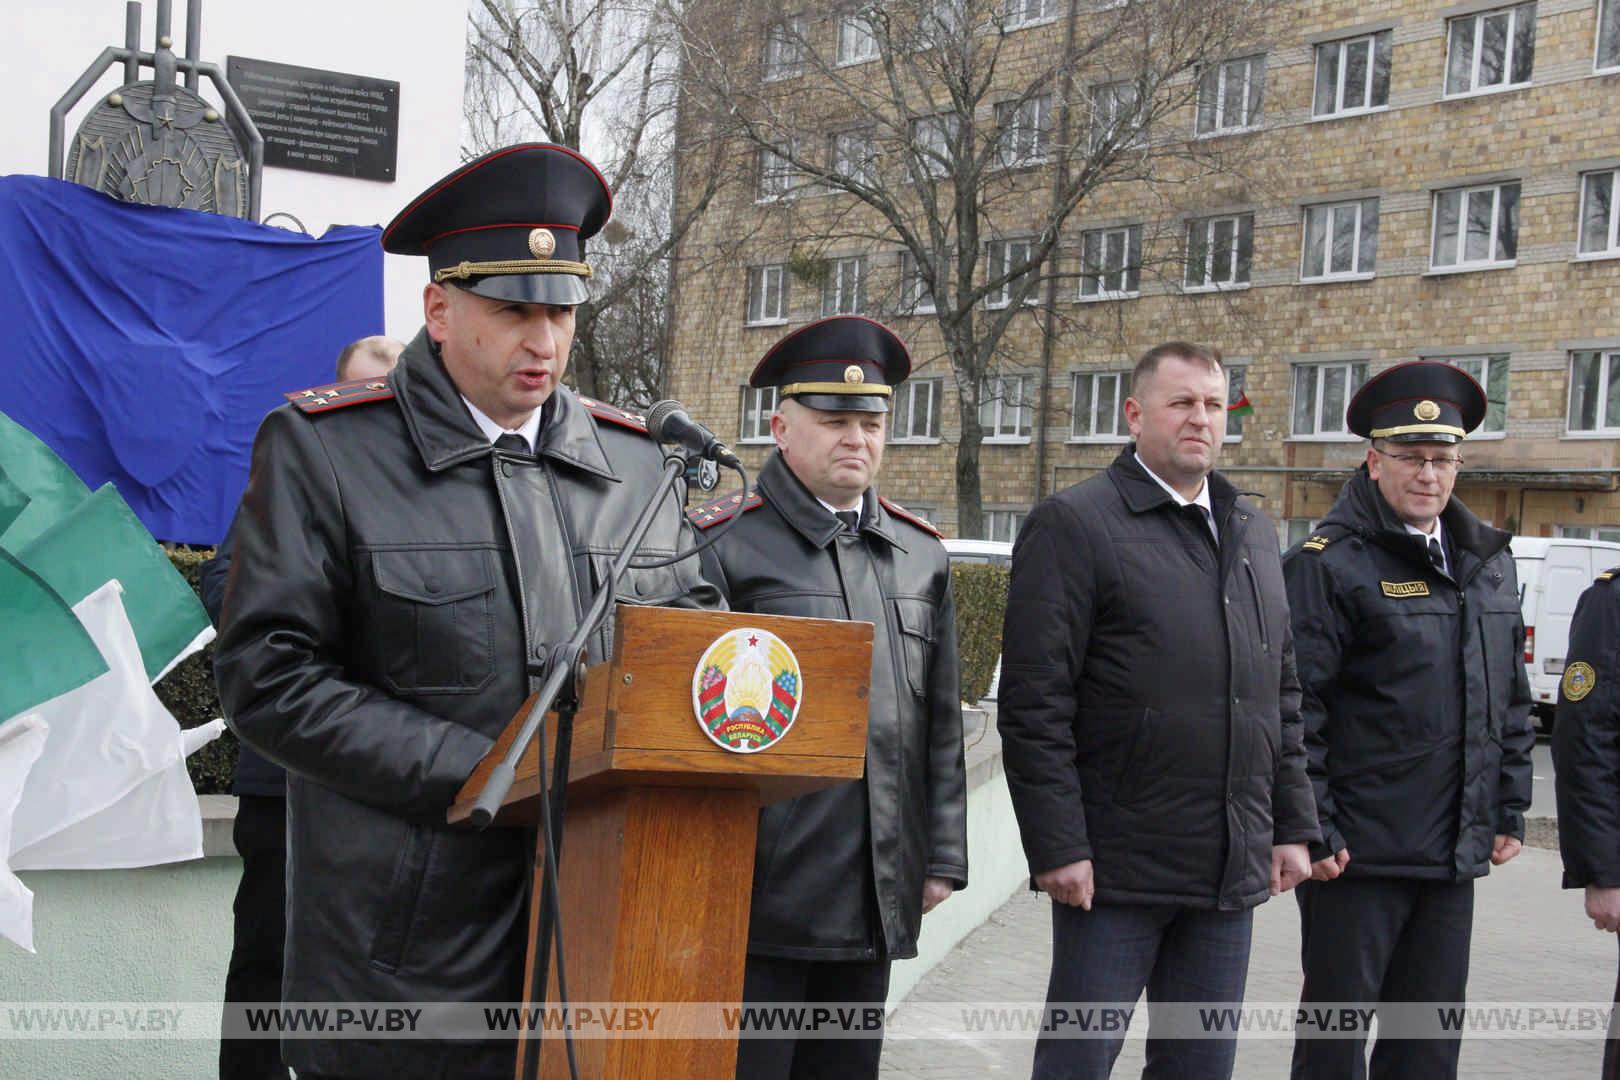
[1293, 880, 1474, 1080]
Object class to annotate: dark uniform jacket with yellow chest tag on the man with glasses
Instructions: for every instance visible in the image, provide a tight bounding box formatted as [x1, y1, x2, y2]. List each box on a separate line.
[1283, 466, 1534, 881]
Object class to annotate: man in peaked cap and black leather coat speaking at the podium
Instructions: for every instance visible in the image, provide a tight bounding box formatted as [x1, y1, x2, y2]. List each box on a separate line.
[215, 144, 718, 1080]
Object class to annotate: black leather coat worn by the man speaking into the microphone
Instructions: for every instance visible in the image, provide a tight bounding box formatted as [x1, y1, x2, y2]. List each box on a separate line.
[215, 334, 718, 1080]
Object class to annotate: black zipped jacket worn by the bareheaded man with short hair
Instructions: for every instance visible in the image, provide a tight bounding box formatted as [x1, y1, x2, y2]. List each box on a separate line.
[998, 444, 1317, 910]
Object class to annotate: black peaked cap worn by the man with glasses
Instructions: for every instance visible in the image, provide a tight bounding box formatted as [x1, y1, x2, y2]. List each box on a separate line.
[1345, 359, 1487, 442]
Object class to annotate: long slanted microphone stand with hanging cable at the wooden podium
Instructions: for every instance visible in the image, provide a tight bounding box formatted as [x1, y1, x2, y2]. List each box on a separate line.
[468, 449, 693, 1077]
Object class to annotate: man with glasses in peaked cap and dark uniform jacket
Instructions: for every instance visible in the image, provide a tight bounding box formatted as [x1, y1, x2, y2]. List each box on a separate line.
[1283, 361, 1534, 1080]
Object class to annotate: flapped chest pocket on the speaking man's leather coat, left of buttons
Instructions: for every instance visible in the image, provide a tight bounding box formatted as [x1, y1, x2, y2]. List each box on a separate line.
[361, 547, 496, 695]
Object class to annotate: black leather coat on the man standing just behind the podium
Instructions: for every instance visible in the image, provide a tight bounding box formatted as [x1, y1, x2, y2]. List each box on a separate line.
[695, 453, 967, 960]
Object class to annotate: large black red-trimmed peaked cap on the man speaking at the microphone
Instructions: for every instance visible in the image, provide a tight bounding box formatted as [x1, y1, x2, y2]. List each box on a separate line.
[382, 142, 612, 304]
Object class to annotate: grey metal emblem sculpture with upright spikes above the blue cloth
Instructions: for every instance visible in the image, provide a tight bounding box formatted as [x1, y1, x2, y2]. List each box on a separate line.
[50, 0, 264, 220]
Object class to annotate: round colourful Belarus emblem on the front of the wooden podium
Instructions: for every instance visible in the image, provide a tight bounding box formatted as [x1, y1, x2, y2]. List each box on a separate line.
[692, 627, 804, 755]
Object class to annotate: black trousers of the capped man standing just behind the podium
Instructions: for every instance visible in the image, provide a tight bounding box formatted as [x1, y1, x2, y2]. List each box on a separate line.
[737, 955, 889, 1080]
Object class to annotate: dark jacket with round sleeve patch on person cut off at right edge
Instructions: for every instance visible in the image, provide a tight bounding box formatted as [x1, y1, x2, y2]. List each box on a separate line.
[1552, 567, 1620, 889]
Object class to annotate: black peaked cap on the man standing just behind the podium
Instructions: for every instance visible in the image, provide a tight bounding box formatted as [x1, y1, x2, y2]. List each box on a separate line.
[748, 316, 910, 413]
